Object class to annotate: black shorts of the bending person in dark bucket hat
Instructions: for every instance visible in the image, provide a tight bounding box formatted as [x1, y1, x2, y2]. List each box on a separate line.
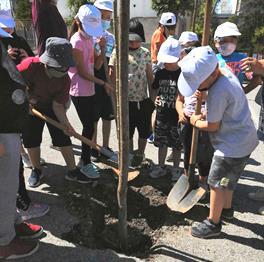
[22, 109, 71, 148]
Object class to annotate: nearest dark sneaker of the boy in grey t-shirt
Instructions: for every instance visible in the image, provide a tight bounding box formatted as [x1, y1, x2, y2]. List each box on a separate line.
[191, 219, 222, 238]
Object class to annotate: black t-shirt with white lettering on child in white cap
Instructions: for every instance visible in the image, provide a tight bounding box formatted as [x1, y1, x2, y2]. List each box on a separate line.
[153, 68, 181, 109]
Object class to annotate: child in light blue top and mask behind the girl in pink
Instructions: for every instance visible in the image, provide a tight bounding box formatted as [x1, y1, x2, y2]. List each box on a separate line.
[91, 0, 115, 161]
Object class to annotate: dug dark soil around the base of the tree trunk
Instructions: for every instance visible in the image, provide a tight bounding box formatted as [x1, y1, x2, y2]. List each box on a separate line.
[58, 159, 207, 258]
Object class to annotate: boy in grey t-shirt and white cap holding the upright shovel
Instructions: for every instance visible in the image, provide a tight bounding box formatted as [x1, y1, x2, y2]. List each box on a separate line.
[178, 46, 258, 238]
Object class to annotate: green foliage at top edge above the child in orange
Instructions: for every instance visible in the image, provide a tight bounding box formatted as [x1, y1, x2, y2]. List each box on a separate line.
[152, 0, 194, 15]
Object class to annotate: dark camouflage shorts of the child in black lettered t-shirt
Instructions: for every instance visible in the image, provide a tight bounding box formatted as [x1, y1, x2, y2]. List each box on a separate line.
[154, 107, 182, 150]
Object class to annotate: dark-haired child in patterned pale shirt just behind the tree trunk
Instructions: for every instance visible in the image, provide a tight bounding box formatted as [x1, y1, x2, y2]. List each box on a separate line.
[109, 18, 154, 166]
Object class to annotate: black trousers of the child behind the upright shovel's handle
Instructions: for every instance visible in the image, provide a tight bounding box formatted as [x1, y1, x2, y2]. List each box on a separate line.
[179, 123, 214, 177]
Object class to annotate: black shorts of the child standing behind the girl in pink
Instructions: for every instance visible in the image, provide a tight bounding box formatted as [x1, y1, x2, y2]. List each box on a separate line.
[94, 85, 115, 122]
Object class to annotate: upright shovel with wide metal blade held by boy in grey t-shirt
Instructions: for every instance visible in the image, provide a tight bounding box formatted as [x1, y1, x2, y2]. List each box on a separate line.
[167, 99, 206, 213]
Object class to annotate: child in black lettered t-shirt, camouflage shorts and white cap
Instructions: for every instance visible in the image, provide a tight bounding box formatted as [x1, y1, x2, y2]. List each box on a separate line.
[150, 38, 182, 178]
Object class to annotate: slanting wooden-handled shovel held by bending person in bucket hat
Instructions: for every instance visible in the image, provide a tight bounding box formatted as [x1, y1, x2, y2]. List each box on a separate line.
[31, 108, 139, 181]
